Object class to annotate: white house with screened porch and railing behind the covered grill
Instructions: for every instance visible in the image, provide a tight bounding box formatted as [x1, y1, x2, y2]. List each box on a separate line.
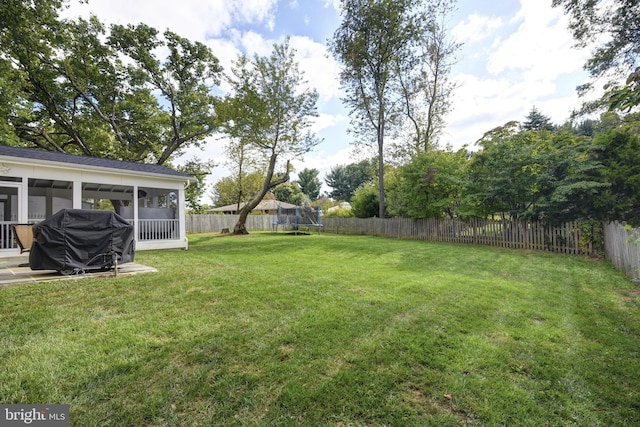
[0, 146, 193, 258]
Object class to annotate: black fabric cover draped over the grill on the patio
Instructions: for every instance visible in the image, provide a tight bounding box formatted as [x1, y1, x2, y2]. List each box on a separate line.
[29, 209, 135, 272]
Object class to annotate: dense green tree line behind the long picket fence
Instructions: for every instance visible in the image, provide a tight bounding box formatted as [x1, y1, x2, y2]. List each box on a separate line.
[327, 108, 640, 225]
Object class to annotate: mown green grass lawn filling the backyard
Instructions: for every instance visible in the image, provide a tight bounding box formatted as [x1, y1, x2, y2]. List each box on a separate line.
[0, 233, 640, 426]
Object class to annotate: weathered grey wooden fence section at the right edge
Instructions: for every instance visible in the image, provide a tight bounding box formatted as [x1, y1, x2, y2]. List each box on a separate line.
[604, 221, 640, 280]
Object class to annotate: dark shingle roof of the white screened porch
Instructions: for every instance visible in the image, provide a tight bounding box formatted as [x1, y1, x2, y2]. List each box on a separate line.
[0, 145, 190, 179]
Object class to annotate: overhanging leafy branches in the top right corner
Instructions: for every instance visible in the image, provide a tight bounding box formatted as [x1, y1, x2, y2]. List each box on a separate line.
[552, 0, 640, 109]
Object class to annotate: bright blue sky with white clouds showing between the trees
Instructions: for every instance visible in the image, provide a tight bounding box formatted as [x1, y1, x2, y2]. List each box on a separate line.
[66, 0, 588, 198]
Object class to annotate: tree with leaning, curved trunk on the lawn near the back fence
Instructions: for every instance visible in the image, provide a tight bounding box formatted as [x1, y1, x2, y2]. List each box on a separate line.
[220, 39, 319, 234]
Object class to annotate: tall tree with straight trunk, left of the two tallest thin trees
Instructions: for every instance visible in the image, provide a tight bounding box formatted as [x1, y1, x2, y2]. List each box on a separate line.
[330, 0, 456, 217]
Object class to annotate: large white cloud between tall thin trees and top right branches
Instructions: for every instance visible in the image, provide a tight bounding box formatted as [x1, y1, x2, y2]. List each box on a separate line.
[442, 0, 588, 148]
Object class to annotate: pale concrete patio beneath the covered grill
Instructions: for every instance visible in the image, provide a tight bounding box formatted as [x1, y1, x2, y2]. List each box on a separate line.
[0, 256, 158, 289]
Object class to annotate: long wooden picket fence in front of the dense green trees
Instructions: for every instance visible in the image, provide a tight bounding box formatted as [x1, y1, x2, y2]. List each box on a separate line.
[322, 217, 597, 255]
